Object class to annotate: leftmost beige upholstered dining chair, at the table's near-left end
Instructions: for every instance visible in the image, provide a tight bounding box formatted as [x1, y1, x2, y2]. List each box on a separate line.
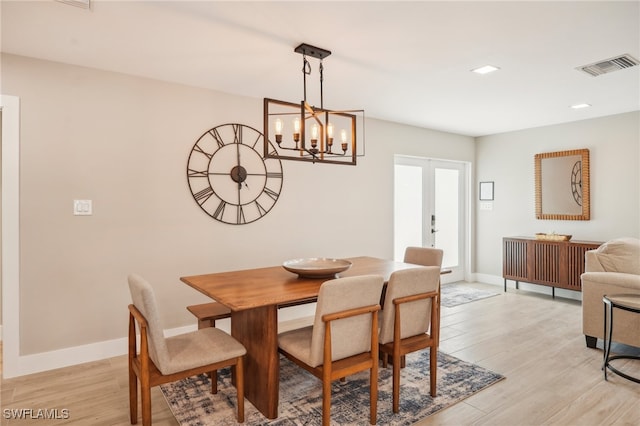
[128, 274, 246, 426]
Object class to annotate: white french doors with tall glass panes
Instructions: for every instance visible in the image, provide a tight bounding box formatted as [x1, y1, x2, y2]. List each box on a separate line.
[394, 156, 468, 282]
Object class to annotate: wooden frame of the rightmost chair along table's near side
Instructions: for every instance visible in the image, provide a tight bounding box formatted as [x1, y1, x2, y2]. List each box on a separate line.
[380, 291, 440, 413]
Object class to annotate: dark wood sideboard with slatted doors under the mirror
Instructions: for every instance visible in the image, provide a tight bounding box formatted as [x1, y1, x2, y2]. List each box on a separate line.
[502, 237, 602, 297]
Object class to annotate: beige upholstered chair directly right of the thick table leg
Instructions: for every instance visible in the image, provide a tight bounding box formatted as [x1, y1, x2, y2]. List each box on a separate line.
[278, 275, 384, 426]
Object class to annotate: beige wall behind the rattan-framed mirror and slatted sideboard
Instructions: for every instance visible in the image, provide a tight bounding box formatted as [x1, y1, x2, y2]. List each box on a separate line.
[475, 111, 640, 277]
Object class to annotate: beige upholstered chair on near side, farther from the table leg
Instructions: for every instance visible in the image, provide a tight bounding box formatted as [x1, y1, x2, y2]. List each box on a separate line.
[379, 266, 440, 413]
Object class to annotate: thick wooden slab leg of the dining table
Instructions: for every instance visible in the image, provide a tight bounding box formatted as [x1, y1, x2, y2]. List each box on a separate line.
[231, 305, 280, 419]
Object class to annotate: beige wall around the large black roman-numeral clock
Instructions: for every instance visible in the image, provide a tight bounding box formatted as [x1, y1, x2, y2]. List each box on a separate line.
[2, 55, 475, 355]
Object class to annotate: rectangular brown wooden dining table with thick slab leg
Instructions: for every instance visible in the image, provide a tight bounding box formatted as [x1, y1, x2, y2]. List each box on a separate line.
[180, 256, 428, 419]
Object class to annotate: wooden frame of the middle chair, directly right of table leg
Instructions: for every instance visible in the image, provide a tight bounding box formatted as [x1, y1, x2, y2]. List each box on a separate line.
[279, 304, 380, 426]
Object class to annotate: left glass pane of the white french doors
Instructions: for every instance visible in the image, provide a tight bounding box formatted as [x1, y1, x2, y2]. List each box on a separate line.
[394, 164, 423, 260]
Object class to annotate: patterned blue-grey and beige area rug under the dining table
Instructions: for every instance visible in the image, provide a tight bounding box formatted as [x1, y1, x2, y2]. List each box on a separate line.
[161, 350, 504, 426]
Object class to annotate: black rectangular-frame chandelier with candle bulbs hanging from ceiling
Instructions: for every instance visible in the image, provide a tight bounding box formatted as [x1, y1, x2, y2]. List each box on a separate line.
[264, 43, 364, 165]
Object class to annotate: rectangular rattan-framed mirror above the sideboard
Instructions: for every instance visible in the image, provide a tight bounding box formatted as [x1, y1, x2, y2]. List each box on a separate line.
[535, 149, 591, 220]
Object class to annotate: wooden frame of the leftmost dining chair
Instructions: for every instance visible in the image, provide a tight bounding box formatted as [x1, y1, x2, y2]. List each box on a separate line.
[129, 304, 244, 426]
